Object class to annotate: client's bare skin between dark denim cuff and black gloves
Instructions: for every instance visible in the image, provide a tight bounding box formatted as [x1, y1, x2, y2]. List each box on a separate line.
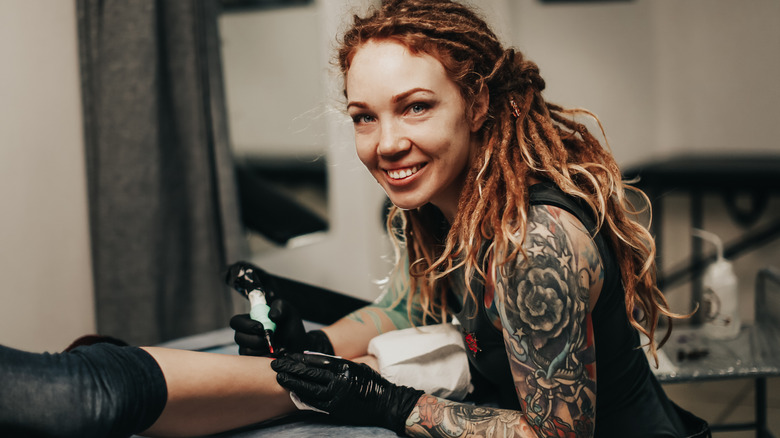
[142, 347, 296, 436]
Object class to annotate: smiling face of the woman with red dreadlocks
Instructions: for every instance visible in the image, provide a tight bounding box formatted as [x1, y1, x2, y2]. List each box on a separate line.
[346, 40, 481, 220]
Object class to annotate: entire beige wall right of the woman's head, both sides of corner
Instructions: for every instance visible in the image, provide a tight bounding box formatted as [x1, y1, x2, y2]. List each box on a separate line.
[502, 0, 780, 162]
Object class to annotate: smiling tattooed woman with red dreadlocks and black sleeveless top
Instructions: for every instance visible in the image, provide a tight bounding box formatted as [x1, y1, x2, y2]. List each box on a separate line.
[232, 0, 707, 437]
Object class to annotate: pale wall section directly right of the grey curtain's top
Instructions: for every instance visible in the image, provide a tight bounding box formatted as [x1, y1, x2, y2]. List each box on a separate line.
[219, 3, 328, 160]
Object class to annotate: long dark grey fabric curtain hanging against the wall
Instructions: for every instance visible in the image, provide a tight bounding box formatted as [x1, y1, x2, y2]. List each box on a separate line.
[77, 0, 243, 345]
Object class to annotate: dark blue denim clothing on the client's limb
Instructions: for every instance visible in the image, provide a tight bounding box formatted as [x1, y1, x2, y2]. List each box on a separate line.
[0, 344, 168, 437]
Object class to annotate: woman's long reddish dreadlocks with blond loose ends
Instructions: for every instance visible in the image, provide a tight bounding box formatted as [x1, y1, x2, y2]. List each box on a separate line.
[337, 0, 683, 360]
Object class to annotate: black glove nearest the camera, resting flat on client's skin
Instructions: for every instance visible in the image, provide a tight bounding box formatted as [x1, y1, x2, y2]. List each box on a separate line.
[271, 353, 424, 435]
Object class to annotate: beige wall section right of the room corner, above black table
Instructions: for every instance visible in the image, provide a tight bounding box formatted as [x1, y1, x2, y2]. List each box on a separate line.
[651, 0, 780, 153]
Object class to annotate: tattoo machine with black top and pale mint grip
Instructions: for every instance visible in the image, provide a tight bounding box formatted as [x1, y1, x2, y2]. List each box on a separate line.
[225, 262, 276, 353]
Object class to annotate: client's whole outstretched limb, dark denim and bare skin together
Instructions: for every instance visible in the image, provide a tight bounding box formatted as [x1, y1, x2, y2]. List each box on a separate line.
[0, 343, 295, 438]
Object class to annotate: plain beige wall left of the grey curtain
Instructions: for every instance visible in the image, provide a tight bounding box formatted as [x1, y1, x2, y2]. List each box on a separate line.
[0, 0, 95, 351]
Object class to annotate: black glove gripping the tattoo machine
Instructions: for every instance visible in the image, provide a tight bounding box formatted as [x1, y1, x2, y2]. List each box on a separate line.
[230, 299, 333, 356]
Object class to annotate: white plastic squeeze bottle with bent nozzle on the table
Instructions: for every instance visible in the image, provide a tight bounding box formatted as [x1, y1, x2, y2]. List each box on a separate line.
[693, 229, 742, 339]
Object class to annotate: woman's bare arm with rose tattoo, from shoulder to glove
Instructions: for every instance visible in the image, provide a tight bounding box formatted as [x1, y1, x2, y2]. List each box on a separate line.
[406, 206, 603, 437]
